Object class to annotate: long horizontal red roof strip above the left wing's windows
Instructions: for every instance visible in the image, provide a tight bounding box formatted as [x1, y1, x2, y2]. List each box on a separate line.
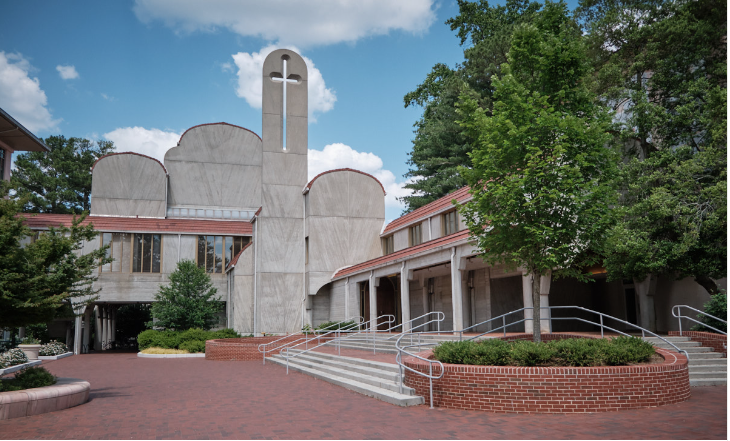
[24, 213, 253, 236]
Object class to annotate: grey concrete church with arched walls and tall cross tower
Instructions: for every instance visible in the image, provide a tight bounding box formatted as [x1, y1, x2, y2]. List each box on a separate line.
[19, 49, 725, 352]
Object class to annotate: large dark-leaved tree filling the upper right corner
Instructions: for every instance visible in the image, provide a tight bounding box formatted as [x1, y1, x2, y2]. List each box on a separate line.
[579, 0, 727, 294]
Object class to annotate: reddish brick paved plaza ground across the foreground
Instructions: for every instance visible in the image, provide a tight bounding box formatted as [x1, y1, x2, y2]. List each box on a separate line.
[0, 353, 727, 439]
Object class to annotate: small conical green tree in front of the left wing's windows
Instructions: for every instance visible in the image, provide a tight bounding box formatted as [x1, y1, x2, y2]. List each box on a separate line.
[150, 260, 223, 330]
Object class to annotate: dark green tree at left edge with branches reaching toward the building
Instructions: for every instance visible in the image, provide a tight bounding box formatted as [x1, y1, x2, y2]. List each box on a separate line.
[0, 185, 111, 327]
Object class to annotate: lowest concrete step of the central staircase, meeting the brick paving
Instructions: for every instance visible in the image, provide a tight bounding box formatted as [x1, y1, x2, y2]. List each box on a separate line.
[269, 356, 424, 406]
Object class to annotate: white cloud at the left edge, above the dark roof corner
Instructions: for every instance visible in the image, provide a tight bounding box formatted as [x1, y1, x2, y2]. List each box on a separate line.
[0, 51, 61, 132]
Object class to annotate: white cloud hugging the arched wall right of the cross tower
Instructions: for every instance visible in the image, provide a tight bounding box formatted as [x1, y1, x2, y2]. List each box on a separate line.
[308, 143, 412, 209]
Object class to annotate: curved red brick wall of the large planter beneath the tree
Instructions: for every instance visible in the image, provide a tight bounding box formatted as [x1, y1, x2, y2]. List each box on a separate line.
[404, 334, 690, 413]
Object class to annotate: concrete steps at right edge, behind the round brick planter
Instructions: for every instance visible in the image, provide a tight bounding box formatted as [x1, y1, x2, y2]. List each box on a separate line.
[644, 337, 727, 386]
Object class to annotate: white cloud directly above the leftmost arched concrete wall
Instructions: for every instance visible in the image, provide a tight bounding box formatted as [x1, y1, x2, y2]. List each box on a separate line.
[103, 127, 180, 162]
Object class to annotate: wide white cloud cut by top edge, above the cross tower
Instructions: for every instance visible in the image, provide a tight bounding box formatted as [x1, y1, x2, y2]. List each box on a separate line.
[133, 0, 436, 47]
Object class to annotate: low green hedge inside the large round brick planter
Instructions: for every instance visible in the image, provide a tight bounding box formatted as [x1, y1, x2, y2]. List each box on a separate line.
[433, 337, 655, 367]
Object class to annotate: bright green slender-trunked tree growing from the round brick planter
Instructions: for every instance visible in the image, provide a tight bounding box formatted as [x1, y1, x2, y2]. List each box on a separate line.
[460, 2, 617, 342]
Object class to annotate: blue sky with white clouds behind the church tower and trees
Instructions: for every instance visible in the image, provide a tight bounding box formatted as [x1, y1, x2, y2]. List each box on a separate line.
[0, 0, 572, 220]
